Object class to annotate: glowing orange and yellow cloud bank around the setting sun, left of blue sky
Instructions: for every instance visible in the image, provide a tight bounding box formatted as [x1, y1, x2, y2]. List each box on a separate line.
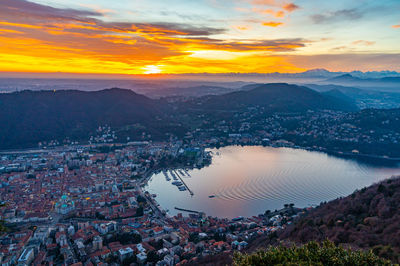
[0, 0, 307, 74]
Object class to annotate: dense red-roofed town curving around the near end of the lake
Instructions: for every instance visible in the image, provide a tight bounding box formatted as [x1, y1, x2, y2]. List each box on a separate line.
[0, 141, 303, 265]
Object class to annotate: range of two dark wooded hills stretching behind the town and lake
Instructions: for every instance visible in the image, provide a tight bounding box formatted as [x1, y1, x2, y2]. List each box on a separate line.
[0, 83, 357, 149]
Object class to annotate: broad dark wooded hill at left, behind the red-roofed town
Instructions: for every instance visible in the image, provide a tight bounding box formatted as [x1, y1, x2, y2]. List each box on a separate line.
[0, 89, 184, 149]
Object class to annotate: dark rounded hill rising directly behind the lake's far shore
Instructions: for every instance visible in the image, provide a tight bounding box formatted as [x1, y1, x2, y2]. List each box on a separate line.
[184, 83, 357, 112]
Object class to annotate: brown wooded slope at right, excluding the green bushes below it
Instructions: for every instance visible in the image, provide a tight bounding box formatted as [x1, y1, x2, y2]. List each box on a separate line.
[278, 177, 400, 263]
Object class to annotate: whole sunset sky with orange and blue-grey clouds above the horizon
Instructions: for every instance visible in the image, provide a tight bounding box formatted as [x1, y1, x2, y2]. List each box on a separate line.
[0, 0, 400, 74]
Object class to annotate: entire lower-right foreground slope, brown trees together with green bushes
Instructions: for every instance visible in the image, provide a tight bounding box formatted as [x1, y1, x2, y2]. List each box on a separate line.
[199, 177, 400, 266]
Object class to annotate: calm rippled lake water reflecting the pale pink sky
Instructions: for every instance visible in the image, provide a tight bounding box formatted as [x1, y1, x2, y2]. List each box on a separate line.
[146, 146, 400, 218]
